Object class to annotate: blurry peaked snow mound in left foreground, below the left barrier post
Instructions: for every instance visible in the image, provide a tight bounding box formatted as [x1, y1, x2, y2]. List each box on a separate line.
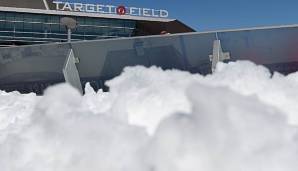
[0, 84, 148, 171]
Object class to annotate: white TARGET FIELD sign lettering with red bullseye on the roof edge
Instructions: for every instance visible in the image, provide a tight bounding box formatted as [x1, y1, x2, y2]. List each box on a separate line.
[53, 1, 169, 18]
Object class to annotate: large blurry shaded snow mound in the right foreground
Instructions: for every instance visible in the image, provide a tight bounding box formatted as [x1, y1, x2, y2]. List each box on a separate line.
[145, 84, 298, 171]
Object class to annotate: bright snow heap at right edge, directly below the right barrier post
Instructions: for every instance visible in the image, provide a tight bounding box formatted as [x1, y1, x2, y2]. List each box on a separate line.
[205, 62, 298, 125]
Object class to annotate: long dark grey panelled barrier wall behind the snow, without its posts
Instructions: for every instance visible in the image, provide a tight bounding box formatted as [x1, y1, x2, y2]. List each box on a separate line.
[0, 26, 298, 93]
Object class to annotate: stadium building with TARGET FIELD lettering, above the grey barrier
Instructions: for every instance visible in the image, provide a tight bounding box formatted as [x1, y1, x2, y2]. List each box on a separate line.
[0, 0, 194, 46]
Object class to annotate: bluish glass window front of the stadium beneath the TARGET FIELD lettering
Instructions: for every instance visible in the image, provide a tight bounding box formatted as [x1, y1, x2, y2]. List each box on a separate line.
[0, 12, 136, 43]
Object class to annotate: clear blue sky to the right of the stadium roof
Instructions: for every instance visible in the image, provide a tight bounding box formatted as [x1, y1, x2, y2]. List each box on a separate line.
[62, 0, 298, 31]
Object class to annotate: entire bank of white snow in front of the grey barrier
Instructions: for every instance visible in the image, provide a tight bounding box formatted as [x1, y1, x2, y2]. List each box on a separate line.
[0, 62, 298, 171]
